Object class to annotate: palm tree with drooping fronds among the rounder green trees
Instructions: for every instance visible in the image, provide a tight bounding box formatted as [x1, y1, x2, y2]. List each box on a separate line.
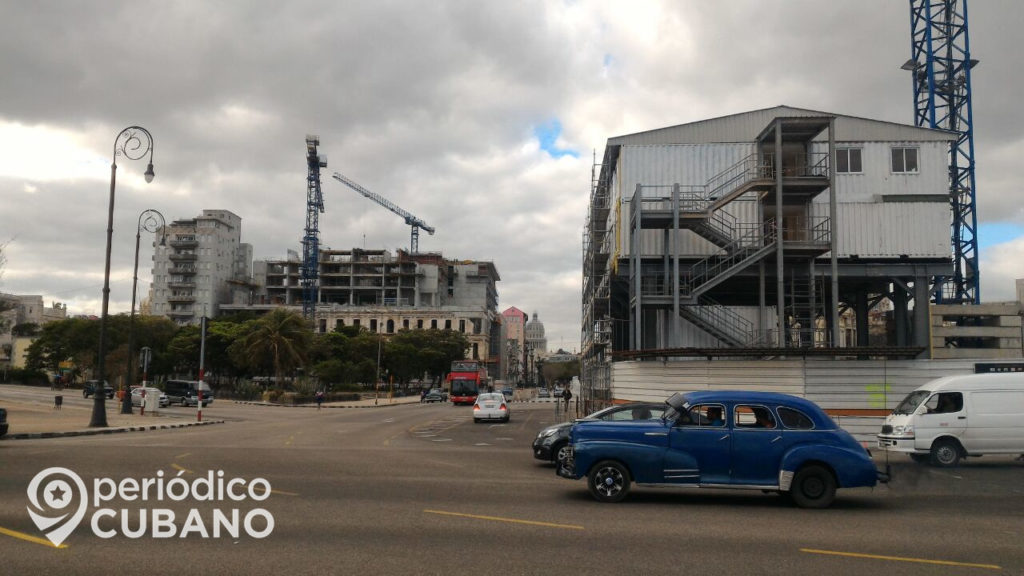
[238, 308, 312, 386]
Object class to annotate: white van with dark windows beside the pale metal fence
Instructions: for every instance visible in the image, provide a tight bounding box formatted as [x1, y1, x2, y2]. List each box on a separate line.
[878, 372, 1024, 466]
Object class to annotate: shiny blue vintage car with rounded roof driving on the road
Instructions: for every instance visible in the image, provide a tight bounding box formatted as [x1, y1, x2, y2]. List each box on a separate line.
[557, 390, 888, 508]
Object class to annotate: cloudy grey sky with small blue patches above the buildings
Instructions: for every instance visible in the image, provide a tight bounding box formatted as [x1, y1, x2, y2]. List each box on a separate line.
[0, 0, 1024, 349]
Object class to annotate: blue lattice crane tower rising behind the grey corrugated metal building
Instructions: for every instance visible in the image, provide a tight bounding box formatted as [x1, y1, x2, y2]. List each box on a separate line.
[901, 0, 981, 304]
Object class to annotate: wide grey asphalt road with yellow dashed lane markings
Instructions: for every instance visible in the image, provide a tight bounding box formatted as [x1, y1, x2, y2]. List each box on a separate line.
[0, 385, 1024, 576]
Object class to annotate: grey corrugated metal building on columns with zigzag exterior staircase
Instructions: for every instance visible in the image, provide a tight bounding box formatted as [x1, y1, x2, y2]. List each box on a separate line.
[583, 106, 1003, 404]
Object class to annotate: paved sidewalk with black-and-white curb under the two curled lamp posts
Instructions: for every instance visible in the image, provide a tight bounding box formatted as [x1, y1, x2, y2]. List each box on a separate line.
[0, 393, 223, 442]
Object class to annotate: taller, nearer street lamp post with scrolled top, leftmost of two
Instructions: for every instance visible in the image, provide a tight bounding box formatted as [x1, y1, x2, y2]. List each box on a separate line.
[89, 126, 154, 428]
